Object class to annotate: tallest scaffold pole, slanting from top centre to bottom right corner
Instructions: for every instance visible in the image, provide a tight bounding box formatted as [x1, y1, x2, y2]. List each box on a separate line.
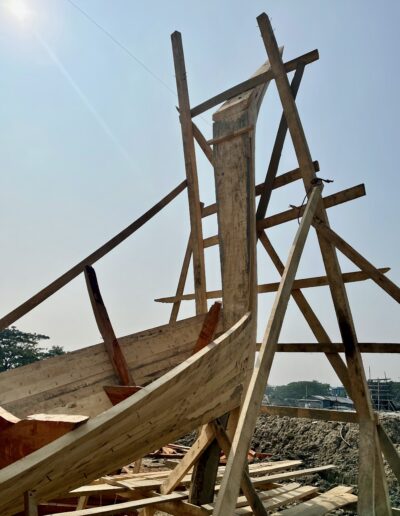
[257, 13, 390, 514]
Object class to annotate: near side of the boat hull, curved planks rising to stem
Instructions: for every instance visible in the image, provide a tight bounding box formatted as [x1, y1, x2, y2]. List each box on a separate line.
[0, 315, 253, 516]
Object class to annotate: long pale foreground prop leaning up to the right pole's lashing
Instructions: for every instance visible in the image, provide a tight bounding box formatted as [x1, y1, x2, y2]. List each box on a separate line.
[214, 184, 323, 516]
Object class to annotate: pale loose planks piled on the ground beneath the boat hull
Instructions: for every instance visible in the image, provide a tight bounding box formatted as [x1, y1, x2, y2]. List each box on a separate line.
[32, 460, 357, 516]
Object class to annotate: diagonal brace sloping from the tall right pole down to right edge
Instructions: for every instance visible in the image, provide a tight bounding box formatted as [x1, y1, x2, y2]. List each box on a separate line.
[313, 219, 400, 303]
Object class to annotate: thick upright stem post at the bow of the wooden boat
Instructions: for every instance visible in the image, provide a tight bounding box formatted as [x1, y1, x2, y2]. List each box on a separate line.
[190, 57, 276, 505]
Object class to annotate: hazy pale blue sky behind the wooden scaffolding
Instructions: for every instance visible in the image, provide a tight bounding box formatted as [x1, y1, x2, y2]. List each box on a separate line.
[0, 0, 400, 384]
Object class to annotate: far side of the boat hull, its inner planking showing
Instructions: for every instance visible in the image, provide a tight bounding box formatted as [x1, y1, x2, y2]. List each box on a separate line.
[0, 315, 212, 418]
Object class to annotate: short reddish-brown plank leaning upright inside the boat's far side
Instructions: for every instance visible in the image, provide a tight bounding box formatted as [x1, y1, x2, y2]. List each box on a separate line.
[85, 265, 135, 386]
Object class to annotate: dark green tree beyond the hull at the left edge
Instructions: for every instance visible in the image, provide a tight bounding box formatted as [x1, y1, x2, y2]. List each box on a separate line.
[0, 326, 64, 372]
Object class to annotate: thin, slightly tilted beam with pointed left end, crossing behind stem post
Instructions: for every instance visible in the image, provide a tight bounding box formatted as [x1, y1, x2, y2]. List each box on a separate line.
[154, 267, 390, 303]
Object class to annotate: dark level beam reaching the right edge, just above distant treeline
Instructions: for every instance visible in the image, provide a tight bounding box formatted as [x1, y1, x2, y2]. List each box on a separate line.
[276, 342, 400, 353]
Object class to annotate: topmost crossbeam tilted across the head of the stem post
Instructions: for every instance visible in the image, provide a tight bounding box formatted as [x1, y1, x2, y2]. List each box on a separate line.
[190, 50, 319, 118]
